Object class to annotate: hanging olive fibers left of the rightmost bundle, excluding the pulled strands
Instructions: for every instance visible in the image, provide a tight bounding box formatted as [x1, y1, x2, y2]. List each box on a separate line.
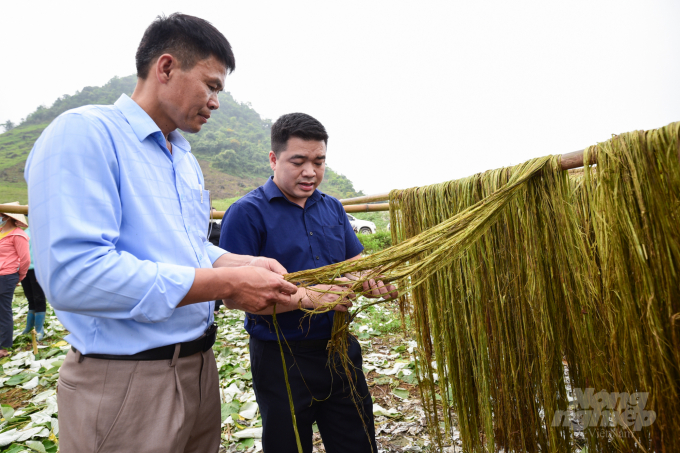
[390, 157, 575, 451]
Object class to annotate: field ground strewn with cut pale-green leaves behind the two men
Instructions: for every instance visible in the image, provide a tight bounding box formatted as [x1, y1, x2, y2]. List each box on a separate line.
[0, 288, 461, 453]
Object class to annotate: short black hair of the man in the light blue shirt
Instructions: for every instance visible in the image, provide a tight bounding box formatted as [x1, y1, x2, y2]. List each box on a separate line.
[136, 13, 236, 79]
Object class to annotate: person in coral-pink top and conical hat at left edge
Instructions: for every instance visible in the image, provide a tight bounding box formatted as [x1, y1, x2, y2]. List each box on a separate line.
[0, 201, 31, 358]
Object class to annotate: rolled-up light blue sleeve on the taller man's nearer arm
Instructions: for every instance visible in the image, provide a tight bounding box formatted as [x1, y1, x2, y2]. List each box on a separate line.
[26, 112, 195, 323]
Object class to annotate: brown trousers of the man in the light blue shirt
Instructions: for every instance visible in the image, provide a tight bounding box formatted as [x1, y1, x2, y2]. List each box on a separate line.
[57, 349, 221, 453]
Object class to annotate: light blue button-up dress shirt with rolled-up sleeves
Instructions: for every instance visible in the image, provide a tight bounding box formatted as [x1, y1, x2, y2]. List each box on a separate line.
[25, 95, 226, 355]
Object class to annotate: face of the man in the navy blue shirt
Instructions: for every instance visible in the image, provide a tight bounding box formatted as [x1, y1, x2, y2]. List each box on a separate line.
[269, 137, 326, 207]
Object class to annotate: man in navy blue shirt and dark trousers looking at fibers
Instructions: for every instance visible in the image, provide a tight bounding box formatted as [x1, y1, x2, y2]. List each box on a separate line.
[220, 113, 394, 453]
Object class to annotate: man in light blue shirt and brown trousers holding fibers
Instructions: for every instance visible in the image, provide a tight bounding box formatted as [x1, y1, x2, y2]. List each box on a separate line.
[25, 14, 297, 452]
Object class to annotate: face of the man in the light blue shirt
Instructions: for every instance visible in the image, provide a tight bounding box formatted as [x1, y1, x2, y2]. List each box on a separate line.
[161, 56, 227, 133]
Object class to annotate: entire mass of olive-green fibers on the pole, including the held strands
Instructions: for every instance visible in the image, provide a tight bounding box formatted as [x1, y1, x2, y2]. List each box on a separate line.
[286, 123, 680, 452]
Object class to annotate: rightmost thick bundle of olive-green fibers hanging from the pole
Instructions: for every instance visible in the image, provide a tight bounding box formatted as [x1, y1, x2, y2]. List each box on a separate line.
[574, 123, 680, 452]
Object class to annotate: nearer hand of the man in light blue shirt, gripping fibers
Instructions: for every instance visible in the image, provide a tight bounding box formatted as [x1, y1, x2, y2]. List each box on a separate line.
[224, 266, 298, 313]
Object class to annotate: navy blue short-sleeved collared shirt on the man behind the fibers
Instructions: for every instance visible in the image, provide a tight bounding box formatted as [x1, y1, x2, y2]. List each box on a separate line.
[220, 177, 364, 341]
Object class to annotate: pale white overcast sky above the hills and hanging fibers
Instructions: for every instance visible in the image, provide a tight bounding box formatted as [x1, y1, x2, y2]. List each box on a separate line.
[0, 0, 680, 194]
